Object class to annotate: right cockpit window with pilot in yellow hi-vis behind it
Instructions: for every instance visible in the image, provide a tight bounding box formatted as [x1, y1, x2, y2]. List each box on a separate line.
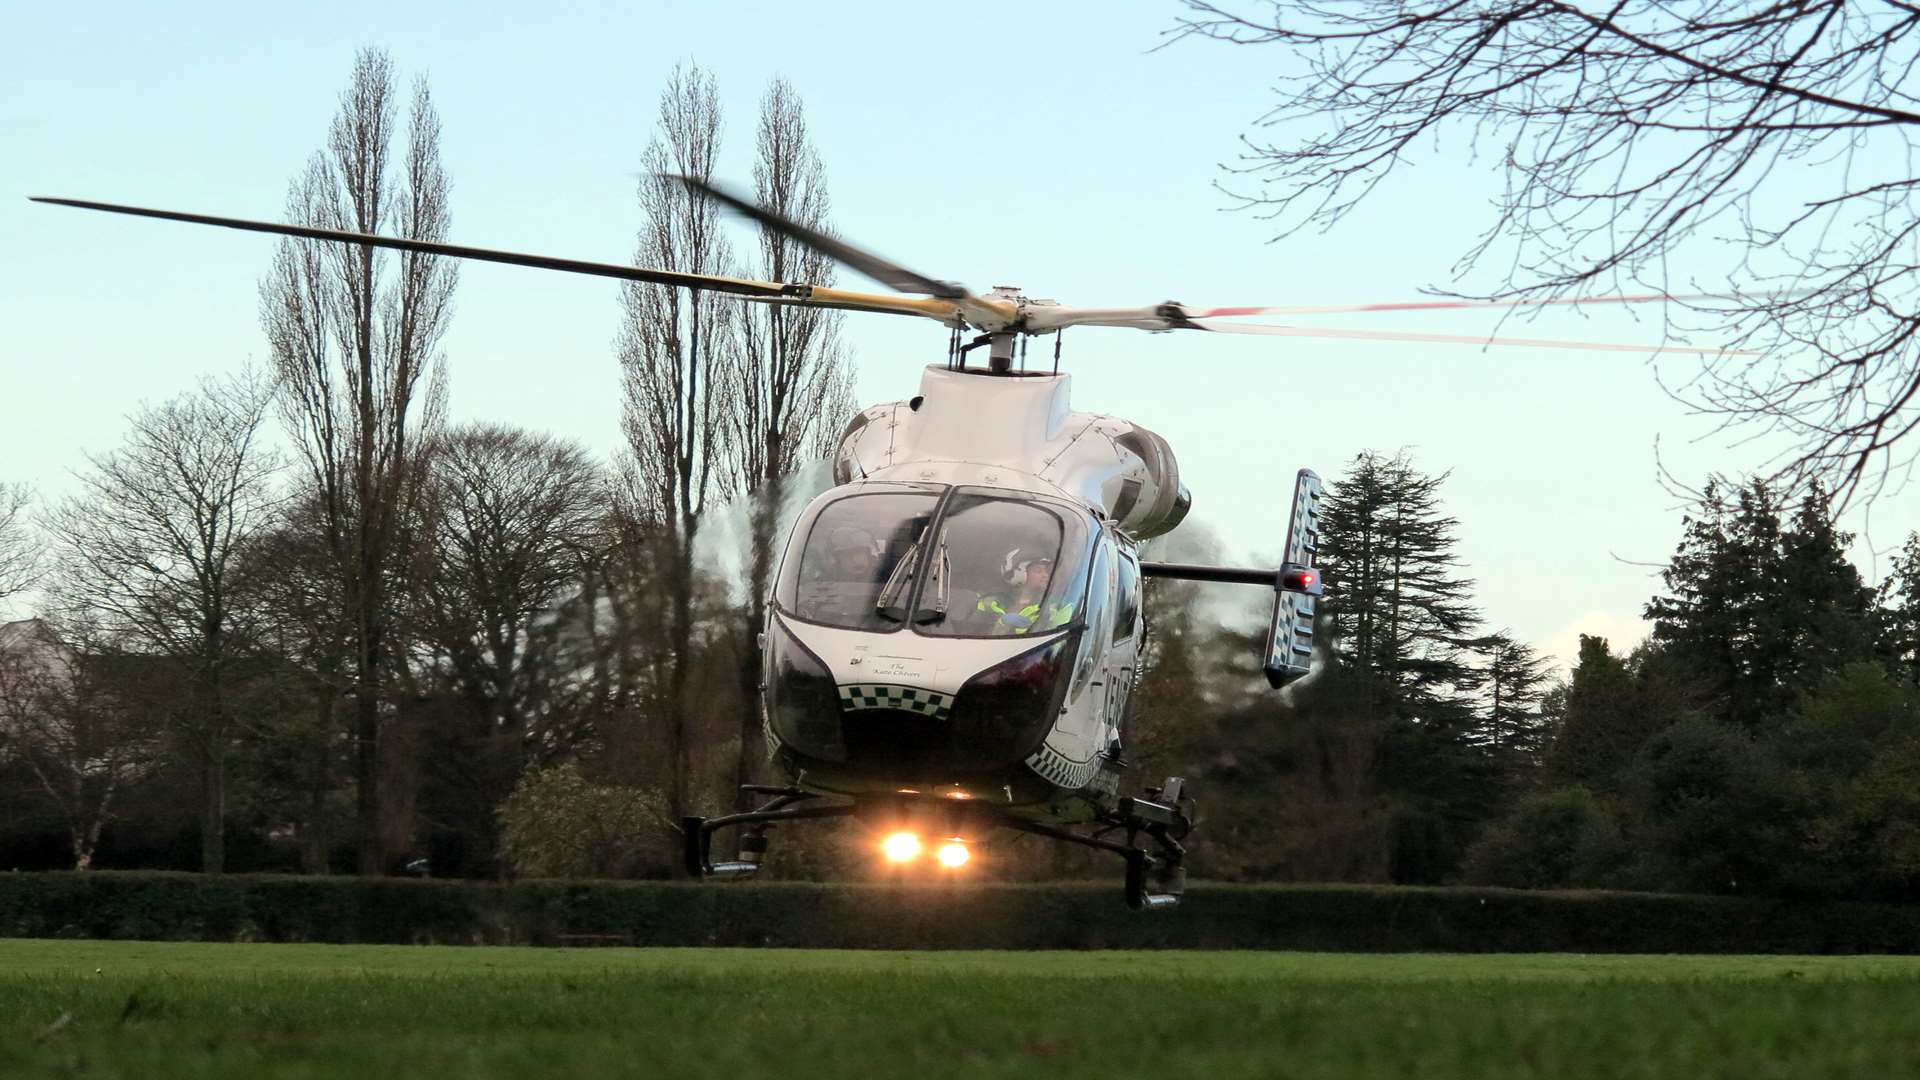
[912, 490, 1087, 638]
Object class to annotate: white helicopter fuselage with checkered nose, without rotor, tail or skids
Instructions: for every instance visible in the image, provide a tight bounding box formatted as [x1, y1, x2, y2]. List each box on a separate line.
[766, 367, 1188, 822]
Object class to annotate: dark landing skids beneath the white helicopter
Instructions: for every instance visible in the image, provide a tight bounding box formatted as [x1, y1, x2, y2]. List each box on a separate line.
[680, 776, 1192, 911]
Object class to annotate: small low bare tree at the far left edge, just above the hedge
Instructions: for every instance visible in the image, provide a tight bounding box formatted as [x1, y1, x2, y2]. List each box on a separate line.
[0, 619, 167, 871]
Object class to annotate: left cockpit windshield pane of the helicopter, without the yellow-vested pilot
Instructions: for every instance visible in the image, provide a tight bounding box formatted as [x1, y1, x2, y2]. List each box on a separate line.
[776, 492, 939, 630]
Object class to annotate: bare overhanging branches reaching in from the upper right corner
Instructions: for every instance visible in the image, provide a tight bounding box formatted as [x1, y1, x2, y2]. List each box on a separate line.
[1173, 0, 1920, 498]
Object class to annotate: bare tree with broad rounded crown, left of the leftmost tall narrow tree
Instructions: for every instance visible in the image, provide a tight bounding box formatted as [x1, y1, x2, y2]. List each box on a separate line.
[46, 373, 280, 872]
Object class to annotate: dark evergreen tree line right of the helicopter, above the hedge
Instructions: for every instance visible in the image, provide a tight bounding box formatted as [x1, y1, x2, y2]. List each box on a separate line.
[1137, 454, 1920, 899]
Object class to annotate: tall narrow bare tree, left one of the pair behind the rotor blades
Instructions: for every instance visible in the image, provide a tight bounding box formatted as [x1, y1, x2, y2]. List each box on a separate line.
[616, 65, 737, 815]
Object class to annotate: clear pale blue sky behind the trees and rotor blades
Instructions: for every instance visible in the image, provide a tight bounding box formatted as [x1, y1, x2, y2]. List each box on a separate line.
[0, 2, 1920, 657]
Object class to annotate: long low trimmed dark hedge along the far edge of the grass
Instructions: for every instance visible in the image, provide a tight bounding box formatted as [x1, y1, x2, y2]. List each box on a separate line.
[0, 871, 1920, 953]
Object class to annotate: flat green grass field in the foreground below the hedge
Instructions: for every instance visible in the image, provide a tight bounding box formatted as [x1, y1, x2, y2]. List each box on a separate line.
[0, 940, 1920, 1080]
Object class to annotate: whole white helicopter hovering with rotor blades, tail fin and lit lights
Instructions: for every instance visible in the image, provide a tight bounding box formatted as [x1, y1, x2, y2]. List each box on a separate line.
[35, 177, 1740, 911]
